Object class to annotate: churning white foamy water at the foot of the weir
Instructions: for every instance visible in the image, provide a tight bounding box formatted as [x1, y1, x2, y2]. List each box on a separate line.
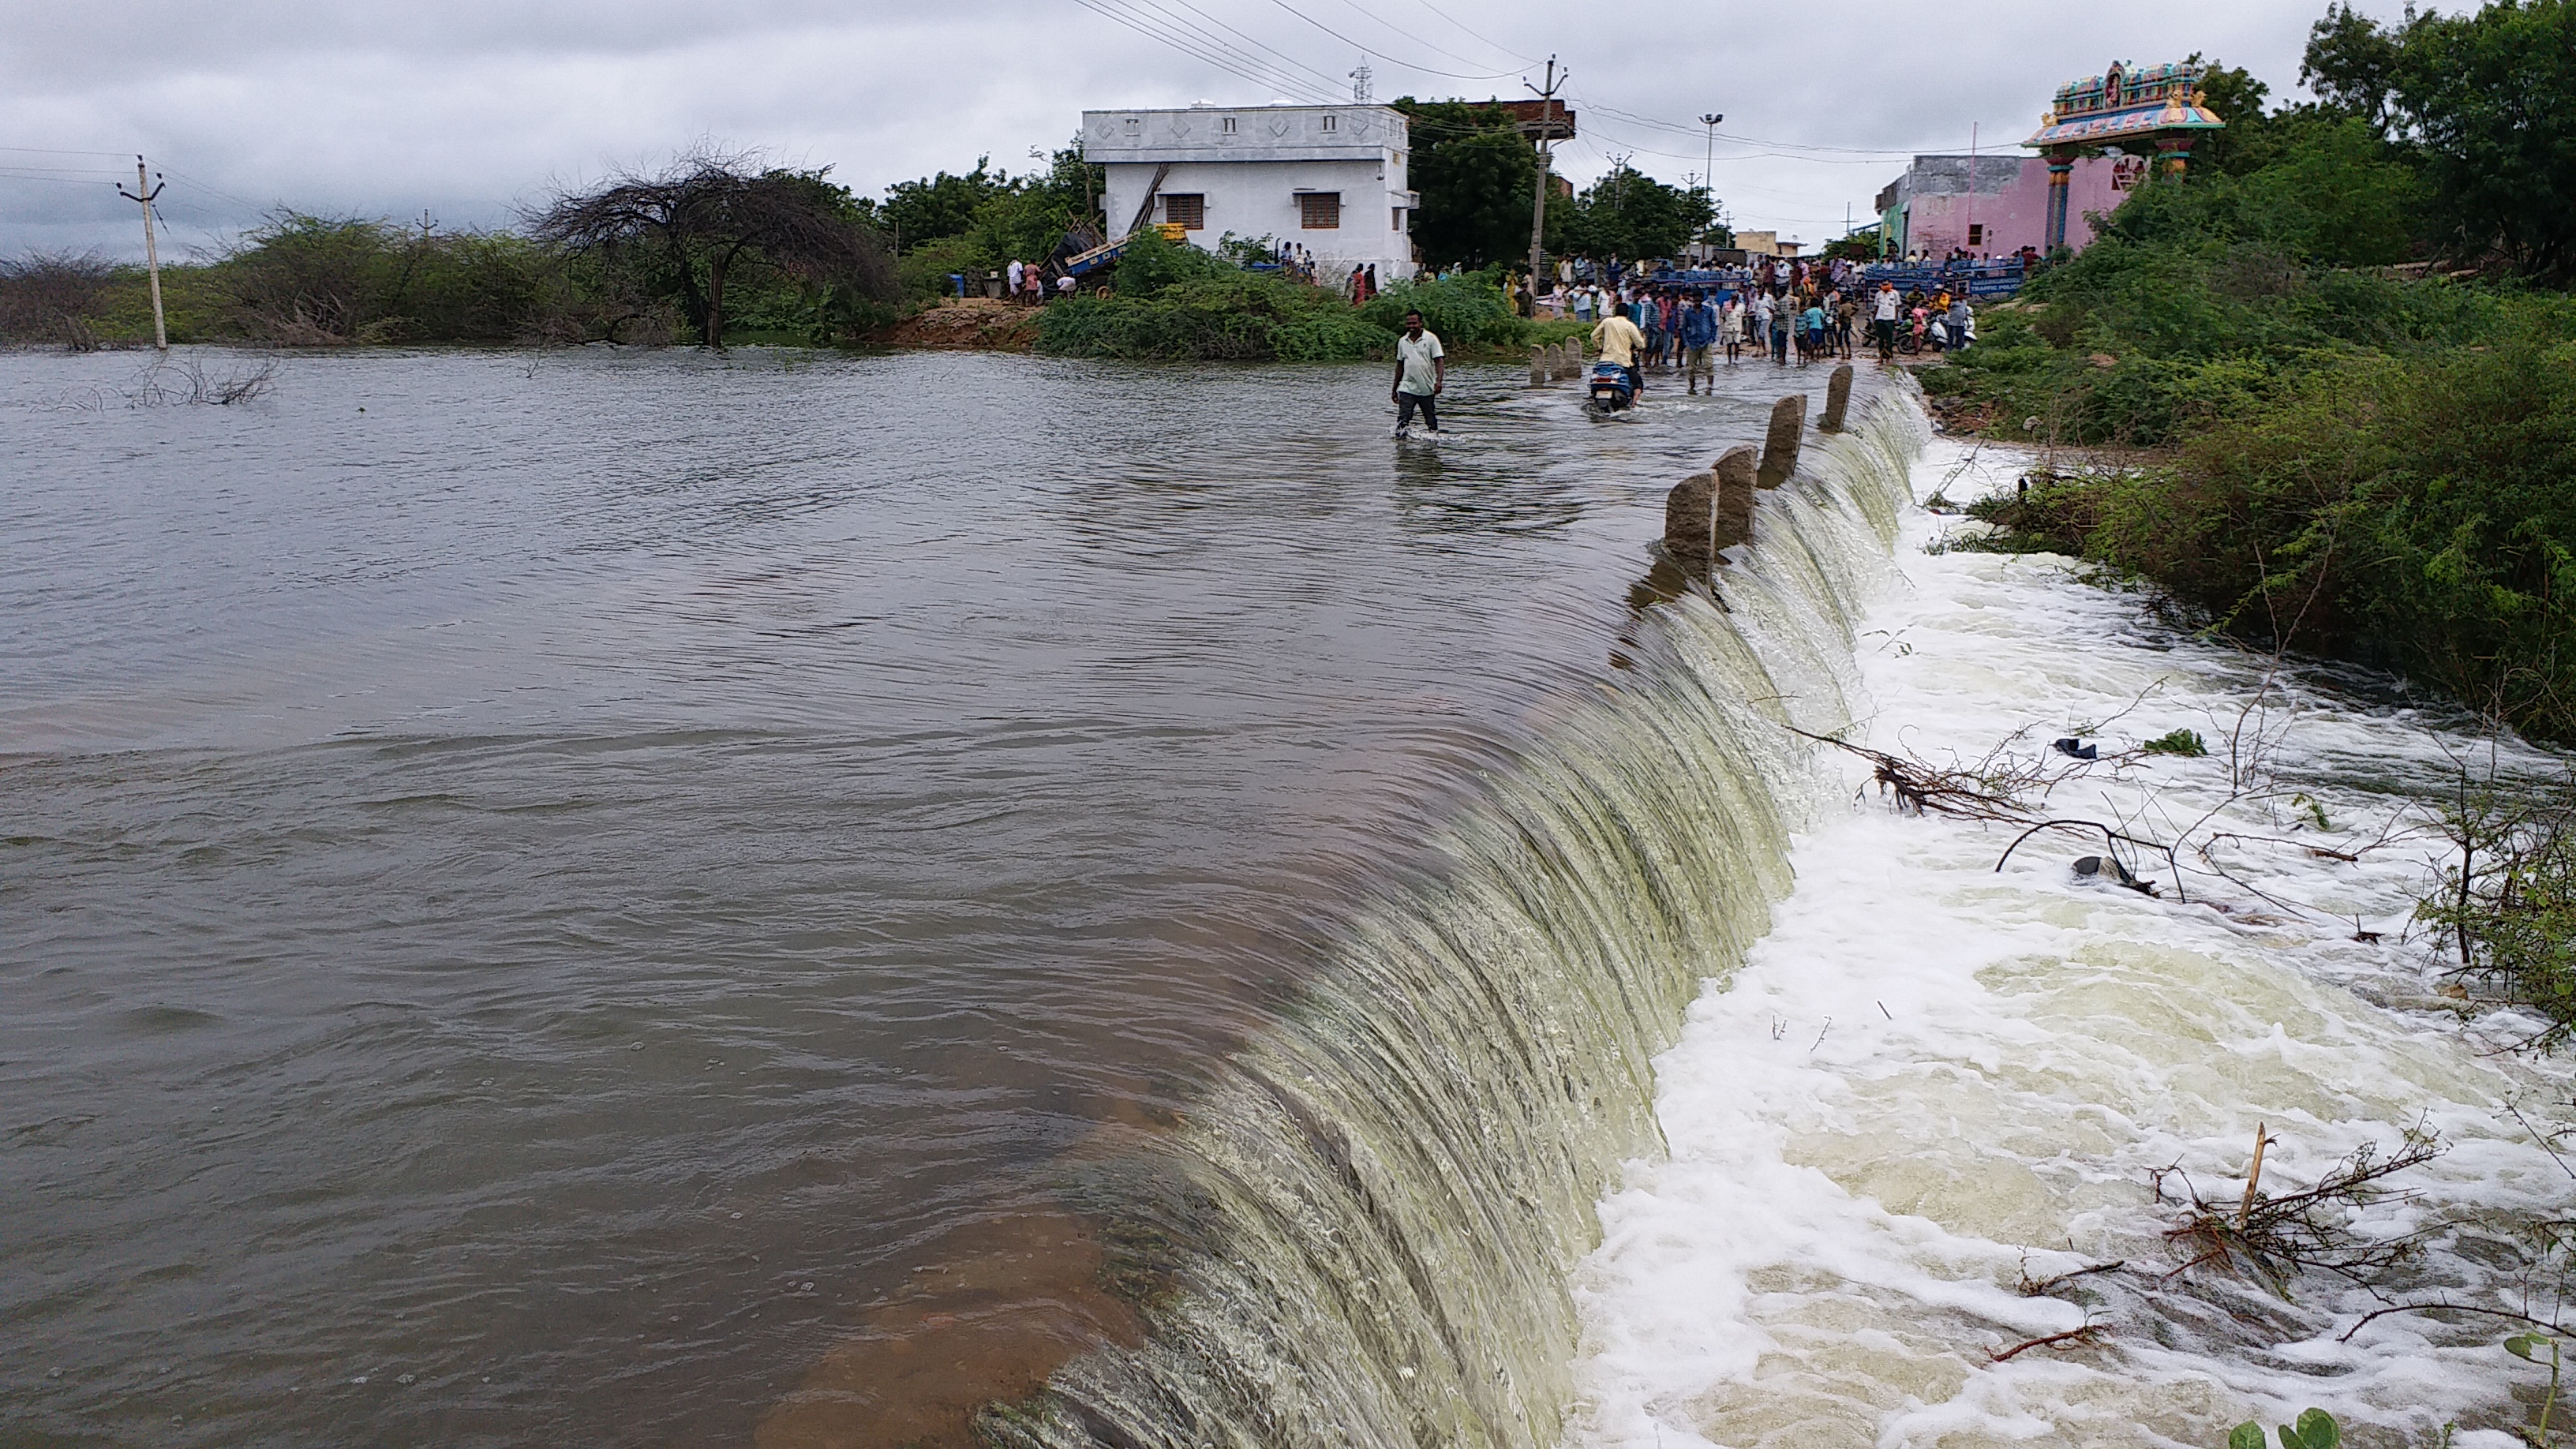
[1569, 441, 2568, 1449]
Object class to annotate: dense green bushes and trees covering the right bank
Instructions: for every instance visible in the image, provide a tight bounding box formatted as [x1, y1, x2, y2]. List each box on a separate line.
[1924, 0, 2576, 743]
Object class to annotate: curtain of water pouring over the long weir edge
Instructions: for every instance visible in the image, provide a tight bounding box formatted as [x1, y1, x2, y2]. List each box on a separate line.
[982, 389, 1926, 1449]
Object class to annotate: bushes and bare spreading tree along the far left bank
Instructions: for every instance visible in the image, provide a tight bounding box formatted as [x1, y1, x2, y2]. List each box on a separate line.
[0, 155, 897, 350]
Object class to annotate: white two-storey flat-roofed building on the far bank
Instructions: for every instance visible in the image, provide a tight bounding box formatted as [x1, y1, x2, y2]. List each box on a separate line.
[1082, 106, 1422, 281]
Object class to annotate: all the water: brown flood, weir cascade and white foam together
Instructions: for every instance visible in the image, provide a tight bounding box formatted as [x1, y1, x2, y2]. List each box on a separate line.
[0, 340, 2563, 1449]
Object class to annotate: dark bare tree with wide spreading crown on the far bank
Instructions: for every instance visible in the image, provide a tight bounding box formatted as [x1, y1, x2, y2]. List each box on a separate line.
[530, 149, 894, 350]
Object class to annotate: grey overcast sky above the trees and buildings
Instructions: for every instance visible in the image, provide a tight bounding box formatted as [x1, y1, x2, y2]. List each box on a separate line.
[0, 0, 2398, 255]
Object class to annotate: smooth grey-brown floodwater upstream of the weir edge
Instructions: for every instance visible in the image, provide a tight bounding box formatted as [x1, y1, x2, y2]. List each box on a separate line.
[0, 348, 1855, 1447]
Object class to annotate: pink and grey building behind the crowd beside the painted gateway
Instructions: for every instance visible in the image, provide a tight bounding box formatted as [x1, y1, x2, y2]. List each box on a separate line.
[1878, 155, 2146, 258]
